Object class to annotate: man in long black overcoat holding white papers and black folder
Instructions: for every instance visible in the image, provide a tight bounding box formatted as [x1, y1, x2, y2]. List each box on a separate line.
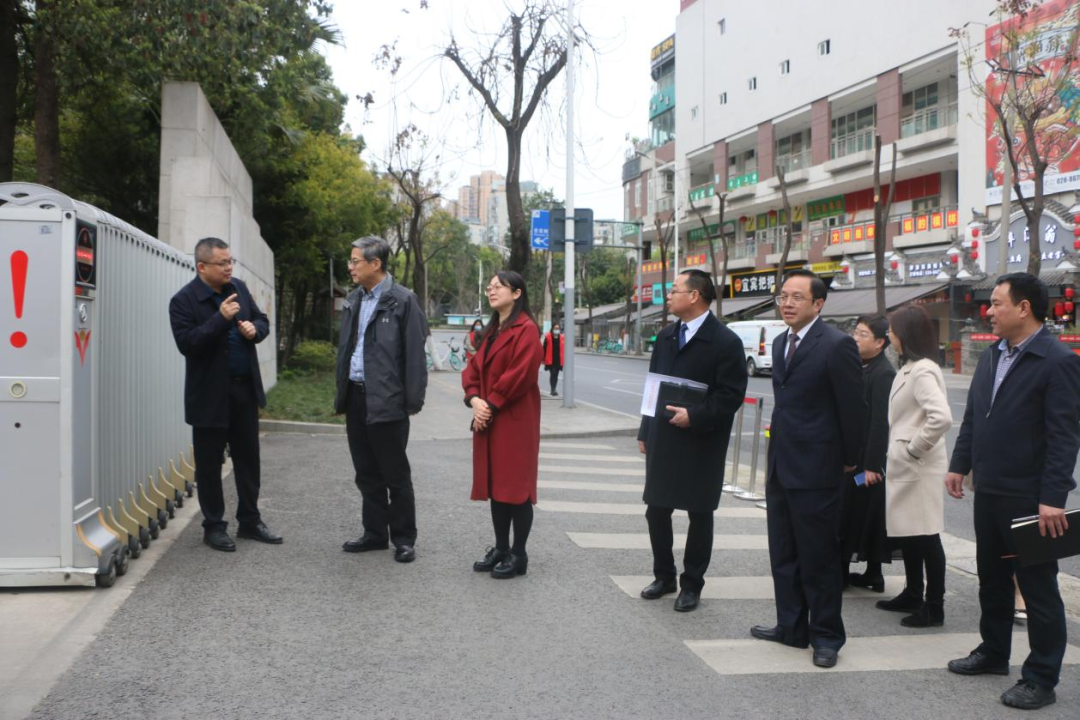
[637, 270, 746, 612]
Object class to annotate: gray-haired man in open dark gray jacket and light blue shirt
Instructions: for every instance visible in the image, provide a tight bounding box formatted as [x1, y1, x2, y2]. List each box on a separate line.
[334, 237, 428, 562]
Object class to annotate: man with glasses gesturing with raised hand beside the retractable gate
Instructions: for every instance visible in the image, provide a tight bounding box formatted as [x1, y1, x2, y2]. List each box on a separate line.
[168, 237, 282, 553]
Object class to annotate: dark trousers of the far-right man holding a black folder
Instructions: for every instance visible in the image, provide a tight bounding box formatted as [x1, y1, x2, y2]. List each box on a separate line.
[975, 492, 1078, 688]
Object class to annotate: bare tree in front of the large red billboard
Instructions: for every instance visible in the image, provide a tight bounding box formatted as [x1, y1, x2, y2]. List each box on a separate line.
[949, 0, 1080, 275]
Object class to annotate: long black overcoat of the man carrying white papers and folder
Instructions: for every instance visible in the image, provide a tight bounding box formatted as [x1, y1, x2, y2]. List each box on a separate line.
[637, 313, 746, 513]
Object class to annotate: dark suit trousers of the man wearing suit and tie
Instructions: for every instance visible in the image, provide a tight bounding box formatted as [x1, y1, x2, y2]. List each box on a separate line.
[765, 475, 847, 650]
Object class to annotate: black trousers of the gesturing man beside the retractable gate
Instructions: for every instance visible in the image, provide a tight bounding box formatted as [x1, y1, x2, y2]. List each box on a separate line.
[191, 378, 261, 530]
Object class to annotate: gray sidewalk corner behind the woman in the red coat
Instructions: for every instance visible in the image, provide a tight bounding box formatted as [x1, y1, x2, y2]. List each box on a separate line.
[259, 371, 640, 441]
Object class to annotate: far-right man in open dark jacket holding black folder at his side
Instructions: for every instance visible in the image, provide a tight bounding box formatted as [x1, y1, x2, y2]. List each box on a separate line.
[945, 272, 1080, 709]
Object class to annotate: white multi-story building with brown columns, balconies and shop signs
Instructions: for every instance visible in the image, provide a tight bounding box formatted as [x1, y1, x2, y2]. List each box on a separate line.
[623, 0, 1080, 342]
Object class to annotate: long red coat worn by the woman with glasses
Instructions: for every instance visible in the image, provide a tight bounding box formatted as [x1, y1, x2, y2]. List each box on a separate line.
[461, 315, 541, 505]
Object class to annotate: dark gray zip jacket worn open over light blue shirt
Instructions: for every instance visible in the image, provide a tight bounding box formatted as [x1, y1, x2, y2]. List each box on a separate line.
[334, 282, 428, 424]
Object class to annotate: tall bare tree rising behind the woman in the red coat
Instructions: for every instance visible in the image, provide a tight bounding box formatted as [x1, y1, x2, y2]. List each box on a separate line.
[443, 0, 589, 272]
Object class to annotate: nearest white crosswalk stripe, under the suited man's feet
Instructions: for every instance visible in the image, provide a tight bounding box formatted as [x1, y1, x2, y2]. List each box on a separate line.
[685, 633, 1080, 675]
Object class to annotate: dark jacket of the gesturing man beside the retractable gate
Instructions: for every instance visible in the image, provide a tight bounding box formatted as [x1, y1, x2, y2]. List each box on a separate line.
[168, 276, 270, 427]
